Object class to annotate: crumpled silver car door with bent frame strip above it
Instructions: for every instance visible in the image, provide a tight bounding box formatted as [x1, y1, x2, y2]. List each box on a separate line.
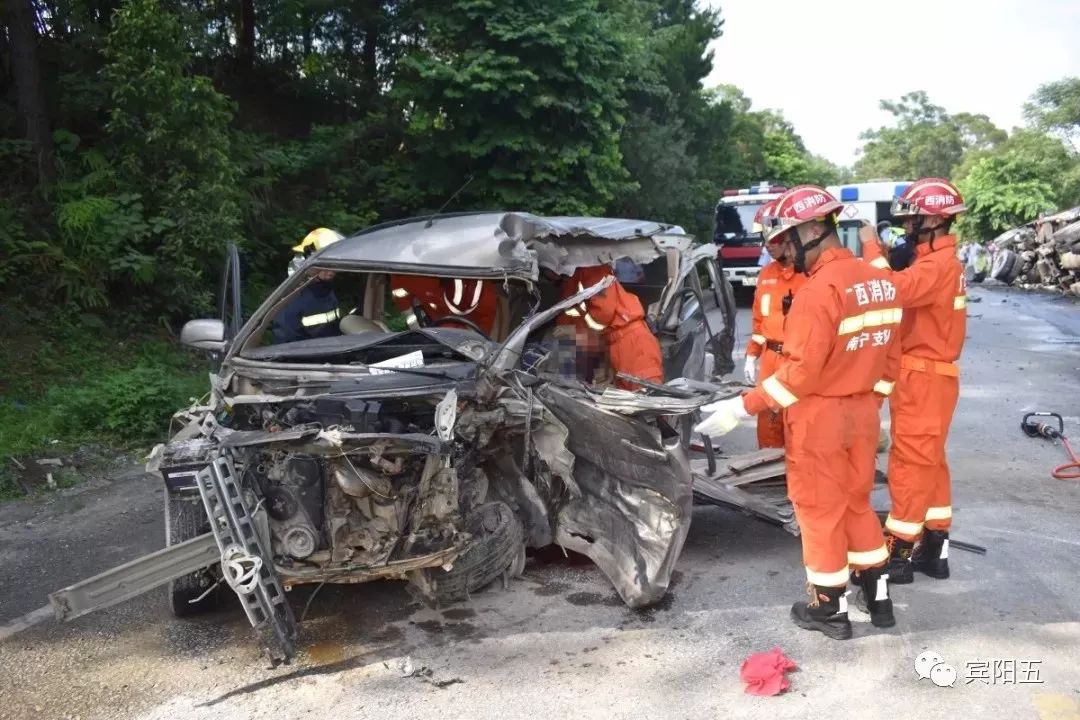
[486, 277, 706, 608]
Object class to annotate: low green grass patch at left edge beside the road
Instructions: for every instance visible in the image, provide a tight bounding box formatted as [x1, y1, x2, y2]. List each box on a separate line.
[0, 307, 208, 500]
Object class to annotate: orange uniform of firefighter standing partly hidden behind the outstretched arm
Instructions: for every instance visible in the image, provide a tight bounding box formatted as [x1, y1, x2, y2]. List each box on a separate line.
[746, 260, 807, 448]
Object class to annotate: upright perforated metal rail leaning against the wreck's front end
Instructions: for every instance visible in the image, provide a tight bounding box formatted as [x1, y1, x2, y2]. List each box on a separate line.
[195, 457, 297, 662]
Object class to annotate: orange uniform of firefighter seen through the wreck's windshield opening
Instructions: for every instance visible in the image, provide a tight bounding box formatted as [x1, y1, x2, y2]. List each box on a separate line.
[390, 275, 498, 334]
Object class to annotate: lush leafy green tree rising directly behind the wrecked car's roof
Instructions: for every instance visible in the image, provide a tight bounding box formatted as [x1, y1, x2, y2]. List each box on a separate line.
[393, 0, 633, 214]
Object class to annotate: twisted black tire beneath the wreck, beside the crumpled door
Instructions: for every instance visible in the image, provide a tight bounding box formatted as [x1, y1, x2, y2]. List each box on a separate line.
[422, 502, 525, 606]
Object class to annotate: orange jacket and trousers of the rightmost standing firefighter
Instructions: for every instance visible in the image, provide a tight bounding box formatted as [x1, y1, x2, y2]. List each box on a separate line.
[863, 235, 968, 542]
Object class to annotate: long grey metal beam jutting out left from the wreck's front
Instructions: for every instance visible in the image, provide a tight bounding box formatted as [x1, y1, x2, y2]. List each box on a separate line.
[49, 532, 220, 622]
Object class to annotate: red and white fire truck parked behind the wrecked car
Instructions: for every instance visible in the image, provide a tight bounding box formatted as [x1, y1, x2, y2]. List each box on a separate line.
[713, 182, 787, 288]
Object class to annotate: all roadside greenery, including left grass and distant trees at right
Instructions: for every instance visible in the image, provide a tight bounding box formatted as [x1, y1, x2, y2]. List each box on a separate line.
[6, 0, 1080, 494]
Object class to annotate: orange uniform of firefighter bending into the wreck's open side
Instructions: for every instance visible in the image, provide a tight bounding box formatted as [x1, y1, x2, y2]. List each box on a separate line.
[558, 267, 664, 390]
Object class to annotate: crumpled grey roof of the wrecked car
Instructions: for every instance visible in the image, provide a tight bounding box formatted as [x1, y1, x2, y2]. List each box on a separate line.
[312, 213, 693, 279]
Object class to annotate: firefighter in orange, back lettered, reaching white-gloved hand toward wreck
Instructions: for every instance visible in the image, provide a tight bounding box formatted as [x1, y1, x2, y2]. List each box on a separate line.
[694, 186, 902, 639]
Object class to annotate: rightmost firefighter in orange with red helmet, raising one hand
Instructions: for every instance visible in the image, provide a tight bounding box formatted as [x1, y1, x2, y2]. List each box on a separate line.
[860, 177, 968, 583]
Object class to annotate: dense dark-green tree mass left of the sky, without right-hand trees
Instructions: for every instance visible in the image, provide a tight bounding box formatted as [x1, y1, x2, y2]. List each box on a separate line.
[0, 0, 839, 327]
